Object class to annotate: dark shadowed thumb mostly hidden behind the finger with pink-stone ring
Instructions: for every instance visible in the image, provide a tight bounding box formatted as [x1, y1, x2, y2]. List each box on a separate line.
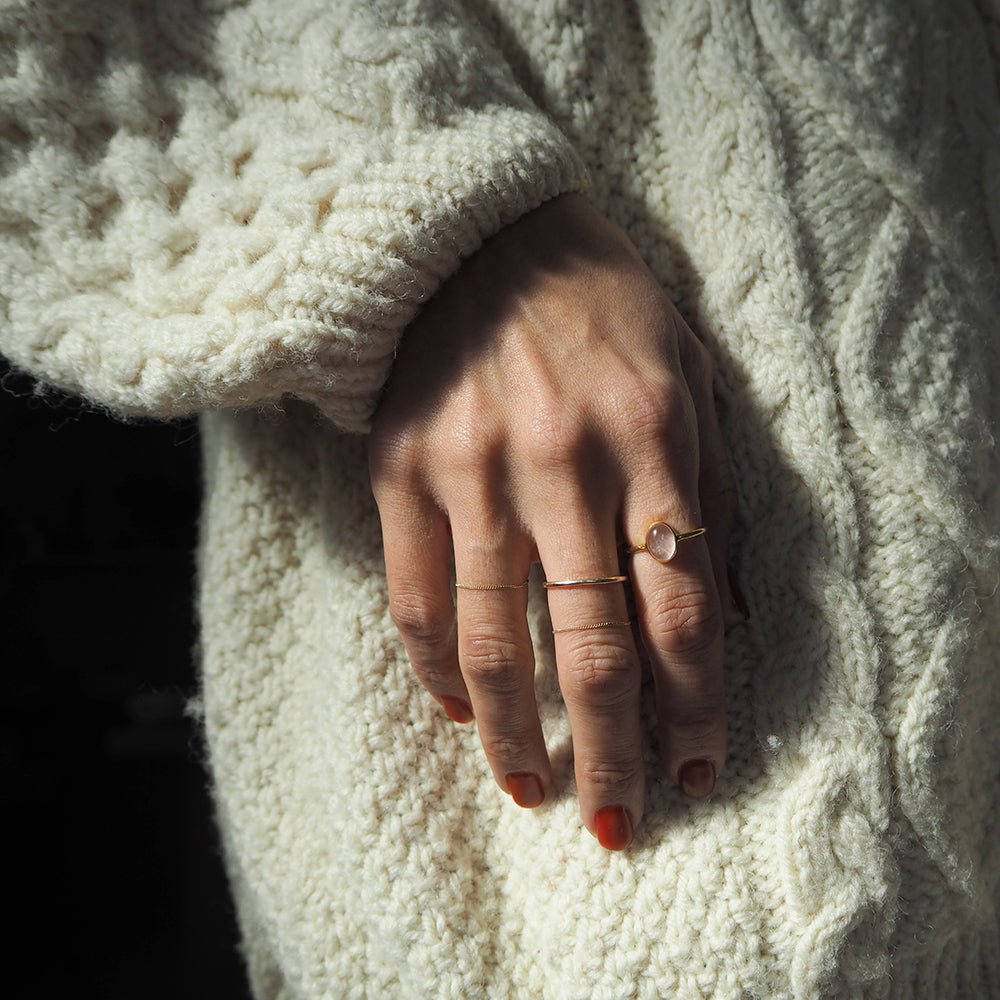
[676, 315, 748, 626]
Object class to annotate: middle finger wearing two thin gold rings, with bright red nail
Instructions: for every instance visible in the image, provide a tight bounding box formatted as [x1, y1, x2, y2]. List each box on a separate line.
[536, 504, 645, 850]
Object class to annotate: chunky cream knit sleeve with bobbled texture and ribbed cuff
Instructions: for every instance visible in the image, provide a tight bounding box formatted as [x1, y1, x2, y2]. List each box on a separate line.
[0, 0, 585, 430]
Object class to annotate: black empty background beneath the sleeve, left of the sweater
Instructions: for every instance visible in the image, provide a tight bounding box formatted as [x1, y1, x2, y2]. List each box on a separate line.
[0, 362, 249, 1000]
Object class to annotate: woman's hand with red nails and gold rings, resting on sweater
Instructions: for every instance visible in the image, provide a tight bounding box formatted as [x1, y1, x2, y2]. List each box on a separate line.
[369, 195, 733, 848]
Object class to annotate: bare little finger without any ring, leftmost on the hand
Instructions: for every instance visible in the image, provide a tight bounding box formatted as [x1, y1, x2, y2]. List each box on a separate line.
[376, 489, 473, 722]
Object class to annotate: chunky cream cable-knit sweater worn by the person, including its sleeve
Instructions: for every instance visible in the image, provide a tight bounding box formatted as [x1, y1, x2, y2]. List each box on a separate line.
[0, 0, 1000, 1000]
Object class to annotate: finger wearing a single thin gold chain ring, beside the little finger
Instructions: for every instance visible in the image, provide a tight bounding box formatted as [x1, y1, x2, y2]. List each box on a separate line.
[452, 505, 552, 808]
